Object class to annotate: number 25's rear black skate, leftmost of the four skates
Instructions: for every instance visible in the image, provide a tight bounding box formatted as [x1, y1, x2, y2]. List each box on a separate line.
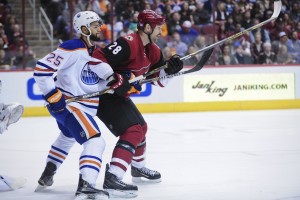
[35, 162, 56, 192]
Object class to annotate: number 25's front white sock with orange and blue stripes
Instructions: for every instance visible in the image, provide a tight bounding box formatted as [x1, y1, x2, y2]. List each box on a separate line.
[79, 137, 105, 186]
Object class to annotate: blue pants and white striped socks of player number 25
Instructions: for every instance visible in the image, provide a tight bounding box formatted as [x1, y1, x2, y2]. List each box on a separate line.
[47, 106, 105, 185]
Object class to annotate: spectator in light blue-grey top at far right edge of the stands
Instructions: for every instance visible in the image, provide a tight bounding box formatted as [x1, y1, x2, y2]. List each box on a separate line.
[287, 30, 300, 63]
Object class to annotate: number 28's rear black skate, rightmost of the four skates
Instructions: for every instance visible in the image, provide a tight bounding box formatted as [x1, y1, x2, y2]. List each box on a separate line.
[131, 166, 161, 183]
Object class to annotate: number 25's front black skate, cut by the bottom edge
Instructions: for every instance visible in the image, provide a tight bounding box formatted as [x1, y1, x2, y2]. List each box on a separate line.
[75, 174, 109, 200]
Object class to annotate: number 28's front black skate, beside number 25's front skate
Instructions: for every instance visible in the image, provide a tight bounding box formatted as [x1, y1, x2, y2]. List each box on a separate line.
[103, 164, 138, 198]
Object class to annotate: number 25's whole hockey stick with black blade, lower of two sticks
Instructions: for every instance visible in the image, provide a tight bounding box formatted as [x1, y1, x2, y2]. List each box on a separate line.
[66, 49, 213, 104]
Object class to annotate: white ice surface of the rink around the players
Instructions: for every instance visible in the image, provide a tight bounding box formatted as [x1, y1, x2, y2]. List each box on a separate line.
[0, 109, 300, 200]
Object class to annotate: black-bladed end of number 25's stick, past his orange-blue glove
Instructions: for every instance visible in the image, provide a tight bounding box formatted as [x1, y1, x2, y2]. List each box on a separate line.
[140, 48, 214, 84]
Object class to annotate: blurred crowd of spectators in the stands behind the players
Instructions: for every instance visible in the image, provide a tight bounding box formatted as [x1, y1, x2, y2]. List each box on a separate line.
[0, 0, 300, 69]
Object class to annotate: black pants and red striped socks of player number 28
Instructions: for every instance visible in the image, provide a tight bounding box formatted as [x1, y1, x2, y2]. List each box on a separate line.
[97, 94, 147, 179]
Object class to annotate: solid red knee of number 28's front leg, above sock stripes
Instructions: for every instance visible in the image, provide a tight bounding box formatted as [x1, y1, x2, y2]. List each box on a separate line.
[120, 124, 145, 148]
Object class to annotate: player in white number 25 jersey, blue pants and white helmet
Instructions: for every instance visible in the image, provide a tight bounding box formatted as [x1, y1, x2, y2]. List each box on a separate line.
[34, 11, 130, 199]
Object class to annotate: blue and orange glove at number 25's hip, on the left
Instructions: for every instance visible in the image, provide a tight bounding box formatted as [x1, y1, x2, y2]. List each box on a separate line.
[44, 88, 66, 113]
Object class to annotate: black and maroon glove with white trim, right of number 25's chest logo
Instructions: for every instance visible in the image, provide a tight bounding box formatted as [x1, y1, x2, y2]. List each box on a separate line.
[107, 73, 130, 96]
